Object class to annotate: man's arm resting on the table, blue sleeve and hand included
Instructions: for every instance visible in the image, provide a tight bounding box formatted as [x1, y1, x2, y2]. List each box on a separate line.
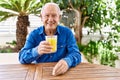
[52, 30, 81, 76]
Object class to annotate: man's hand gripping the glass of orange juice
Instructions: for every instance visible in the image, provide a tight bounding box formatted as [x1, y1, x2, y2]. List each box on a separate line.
[38, 41, 52, 55]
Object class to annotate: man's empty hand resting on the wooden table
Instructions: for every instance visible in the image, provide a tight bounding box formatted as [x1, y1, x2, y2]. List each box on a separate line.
[52, 60, 69, 76]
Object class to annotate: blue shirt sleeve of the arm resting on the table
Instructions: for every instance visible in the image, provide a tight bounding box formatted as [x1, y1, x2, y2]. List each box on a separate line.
[64, 28, 81, 67]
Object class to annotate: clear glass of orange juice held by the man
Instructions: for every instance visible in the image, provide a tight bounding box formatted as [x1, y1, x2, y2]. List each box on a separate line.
[45, 35, 57, 52]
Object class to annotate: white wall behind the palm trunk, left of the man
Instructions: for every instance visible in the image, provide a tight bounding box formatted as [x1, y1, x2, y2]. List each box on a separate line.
[0, 15, 42, 46]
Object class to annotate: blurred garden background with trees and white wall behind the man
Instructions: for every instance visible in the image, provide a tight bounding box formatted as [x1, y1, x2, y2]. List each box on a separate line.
[0, 0, 120, 68]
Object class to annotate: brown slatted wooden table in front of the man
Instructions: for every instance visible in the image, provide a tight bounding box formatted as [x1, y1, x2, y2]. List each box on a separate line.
[0, 63, 120, 80]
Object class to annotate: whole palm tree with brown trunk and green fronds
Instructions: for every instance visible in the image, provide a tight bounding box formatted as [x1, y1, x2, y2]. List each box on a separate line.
[0, 0, 43, 51]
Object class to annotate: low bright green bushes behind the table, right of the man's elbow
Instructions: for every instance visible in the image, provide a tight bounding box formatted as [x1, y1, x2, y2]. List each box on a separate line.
[78, 41, 118, 66]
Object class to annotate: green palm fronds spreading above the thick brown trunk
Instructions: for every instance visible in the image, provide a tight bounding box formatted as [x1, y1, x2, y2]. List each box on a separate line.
[0, 0, 42, 21]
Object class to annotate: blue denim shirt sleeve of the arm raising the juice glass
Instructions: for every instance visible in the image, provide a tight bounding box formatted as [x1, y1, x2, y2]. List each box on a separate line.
[19, 31, 40, 64]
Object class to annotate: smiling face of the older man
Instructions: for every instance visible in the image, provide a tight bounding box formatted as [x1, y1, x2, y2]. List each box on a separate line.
[41, 5, 60, 30]
